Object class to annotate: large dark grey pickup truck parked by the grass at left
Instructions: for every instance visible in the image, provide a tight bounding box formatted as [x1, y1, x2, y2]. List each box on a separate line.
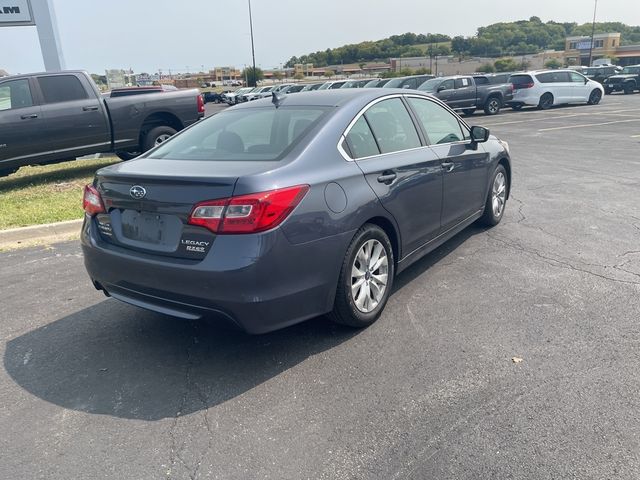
[0, 71, 204, 176]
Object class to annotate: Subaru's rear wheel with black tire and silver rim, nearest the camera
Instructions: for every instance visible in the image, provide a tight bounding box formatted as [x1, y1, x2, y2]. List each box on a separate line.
[329, 223, 395, 328]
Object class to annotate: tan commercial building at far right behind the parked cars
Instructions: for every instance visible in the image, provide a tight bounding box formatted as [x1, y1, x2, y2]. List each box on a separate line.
[564, 33, 640, 66]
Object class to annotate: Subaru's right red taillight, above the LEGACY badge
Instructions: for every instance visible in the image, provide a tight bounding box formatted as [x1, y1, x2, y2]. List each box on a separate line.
[189, 185, 309, 235]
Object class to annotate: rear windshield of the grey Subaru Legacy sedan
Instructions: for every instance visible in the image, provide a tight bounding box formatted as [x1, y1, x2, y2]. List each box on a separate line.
[147, 106, 330, 161]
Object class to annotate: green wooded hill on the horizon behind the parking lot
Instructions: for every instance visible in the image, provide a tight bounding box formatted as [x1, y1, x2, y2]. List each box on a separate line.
[285, 17, 640, 67]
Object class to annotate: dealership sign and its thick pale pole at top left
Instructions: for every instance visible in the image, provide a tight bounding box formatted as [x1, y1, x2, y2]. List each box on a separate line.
[0, 0, 65, 72]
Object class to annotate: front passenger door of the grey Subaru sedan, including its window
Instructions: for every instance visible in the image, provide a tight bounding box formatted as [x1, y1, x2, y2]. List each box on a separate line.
[408, 97, 490, 231]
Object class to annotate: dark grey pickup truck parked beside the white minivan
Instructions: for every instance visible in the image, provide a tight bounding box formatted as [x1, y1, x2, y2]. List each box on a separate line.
[418, 75, 513, 115]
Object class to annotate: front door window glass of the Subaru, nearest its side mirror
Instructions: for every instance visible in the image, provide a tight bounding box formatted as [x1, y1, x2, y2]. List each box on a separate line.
[408, 97, 469, 144]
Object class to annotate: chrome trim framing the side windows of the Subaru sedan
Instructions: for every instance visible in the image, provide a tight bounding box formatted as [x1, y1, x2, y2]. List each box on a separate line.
[337, 93, 471, 162]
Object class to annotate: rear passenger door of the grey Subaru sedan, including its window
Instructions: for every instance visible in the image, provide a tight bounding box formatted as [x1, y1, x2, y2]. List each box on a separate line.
[346, 97, 442, 252]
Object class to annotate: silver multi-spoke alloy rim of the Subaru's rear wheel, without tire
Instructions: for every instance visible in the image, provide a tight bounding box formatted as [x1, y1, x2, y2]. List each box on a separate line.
[351, 239, 389, 313]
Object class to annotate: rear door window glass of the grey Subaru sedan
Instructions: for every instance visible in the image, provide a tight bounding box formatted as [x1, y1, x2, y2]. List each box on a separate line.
[364, 98, 422, 153]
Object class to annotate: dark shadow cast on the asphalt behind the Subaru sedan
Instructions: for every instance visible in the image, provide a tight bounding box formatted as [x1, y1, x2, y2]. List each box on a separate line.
[4, 300, 358, 420]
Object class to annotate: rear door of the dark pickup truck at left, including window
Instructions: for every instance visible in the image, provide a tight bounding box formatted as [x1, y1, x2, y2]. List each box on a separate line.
[36, 74, 111, 156]
